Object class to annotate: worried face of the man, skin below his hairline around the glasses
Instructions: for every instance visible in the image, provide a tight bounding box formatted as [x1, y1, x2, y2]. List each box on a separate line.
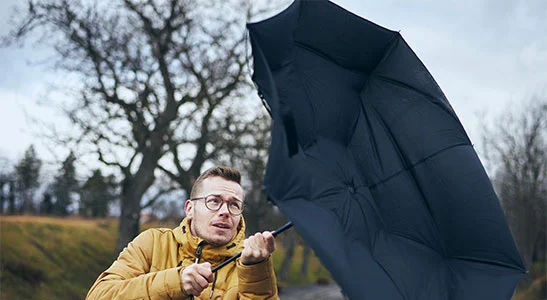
[184, 176, 243, 246]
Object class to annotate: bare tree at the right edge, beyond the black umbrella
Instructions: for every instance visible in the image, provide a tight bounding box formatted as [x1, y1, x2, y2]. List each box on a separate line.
[483, 97, 547, 279]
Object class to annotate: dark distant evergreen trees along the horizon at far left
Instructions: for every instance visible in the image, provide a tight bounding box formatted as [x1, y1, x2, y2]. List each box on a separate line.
[0, 145, 118, 218]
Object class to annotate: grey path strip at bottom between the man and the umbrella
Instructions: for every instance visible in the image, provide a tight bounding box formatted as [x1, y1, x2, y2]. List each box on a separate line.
[279, 283, 344, 300]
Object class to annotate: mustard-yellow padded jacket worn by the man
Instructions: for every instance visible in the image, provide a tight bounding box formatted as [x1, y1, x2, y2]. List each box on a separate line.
[86, 219, 279, 300]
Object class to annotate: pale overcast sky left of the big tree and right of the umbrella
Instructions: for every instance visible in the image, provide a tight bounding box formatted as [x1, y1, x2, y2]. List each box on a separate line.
[0, 0, 547, 172]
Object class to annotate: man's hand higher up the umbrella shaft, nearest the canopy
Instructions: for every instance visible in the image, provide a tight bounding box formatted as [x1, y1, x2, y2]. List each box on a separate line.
[240, 231, 275, 265]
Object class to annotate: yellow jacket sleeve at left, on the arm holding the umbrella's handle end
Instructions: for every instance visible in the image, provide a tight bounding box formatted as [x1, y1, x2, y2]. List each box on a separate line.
[86, 230, 188, 299]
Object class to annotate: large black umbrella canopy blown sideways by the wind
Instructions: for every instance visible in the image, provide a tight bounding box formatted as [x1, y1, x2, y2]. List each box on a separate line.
[248, 0, 525, 299]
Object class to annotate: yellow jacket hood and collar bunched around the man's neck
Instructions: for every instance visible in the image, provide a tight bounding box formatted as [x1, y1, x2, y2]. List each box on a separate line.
[173, 216, 245, 267]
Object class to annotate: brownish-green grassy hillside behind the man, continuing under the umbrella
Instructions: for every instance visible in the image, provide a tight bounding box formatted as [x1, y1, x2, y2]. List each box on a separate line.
[0, 216, 330, 300]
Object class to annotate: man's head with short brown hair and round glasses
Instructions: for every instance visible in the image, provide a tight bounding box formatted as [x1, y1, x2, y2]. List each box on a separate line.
[184, 166, 244, 246]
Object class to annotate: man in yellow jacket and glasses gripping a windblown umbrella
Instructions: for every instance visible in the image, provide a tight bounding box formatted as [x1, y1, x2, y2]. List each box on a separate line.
[87, 167, 279, 299]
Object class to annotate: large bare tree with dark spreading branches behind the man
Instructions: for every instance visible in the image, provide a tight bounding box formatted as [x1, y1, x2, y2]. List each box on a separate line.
[3, 0, 270, 250]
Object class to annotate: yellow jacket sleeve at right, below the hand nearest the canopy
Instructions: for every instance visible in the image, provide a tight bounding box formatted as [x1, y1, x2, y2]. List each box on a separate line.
[237, 256, 279, 300]
